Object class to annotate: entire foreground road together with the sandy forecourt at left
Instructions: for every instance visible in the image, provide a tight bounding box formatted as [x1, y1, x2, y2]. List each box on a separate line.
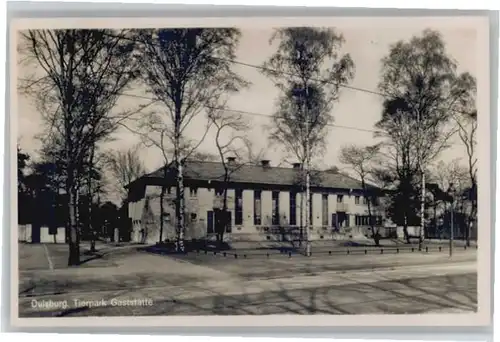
[19, 244, 477, 317]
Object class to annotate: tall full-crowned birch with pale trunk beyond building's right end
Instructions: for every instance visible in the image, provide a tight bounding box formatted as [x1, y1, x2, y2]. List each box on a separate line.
[377, 29, 476, 248]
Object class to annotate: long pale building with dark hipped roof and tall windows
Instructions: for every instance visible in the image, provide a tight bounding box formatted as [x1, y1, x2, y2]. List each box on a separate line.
[127, 158, 383, 243]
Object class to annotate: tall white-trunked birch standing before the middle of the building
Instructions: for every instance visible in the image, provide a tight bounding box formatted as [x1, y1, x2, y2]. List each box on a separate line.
[262, 27, 354, 240]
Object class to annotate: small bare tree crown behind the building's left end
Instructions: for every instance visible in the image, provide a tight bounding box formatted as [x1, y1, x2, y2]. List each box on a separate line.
[106, 146, 147, 199]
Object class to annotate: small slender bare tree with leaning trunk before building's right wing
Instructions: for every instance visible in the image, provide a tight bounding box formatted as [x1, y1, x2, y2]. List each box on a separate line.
[339, 145, 380, 246]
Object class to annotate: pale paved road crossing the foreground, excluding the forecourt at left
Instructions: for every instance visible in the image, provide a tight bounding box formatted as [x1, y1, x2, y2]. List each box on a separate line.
[19, 259, 477, 317]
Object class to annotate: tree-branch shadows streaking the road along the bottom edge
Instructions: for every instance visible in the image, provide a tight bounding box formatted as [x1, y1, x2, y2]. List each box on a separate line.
[20, 274, 477, 317]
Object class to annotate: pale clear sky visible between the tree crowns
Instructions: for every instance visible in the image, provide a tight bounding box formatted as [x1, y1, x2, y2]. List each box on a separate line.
[18, 25, 477, 200]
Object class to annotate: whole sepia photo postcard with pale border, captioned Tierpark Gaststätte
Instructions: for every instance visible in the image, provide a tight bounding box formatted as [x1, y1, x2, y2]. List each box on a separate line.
[11, 17, 491, 325]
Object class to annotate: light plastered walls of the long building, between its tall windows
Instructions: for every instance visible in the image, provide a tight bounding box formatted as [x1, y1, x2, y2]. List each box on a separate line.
[129, 185, 382, 243]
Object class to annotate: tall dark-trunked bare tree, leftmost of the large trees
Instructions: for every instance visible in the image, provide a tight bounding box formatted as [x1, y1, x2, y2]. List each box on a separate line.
[20, 30, 140, 265]
